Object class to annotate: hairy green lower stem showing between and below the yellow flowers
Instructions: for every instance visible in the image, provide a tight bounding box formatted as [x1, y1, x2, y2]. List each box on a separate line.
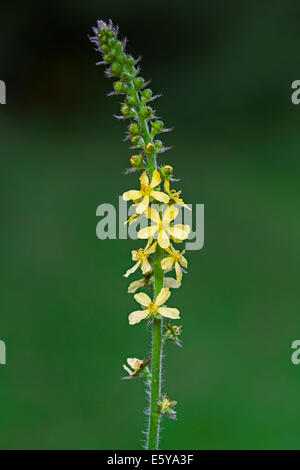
[148, 245, 164, 450]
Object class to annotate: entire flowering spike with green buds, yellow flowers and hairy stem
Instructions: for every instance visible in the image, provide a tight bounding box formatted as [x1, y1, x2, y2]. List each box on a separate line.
[90, 21, 190, 449]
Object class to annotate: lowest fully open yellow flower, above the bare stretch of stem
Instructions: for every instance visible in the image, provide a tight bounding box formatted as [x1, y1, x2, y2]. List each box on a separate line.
[129, 287, 180, 325]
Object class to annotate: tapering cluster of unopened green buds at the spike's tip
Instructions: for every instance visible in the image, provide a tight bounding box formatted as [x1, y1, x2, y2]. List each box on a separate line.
[90, 20, 169, 170]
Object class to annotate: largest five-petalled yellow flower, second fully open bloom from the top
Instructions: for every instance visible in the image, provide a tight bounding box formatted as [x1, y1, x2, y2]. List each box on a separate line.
[138, 206, 191, 248]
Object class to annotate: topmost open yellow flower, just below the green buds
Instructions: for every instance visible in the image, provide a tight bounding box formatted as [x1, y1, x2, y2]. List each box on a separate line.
[123, 170, 170, 214]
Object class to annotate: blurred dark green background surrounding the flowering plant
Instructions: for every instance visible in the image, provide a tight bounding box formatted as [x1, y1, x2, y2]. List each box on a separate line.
[0, 0, 300, 449]
